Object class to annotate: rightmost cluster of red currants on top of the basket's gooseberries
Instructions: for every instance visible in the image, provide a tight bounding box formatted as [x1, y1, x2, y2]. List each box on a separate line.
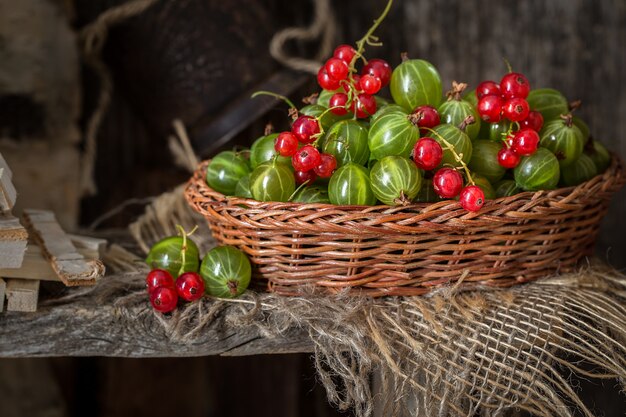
[476, 72, 543, 168]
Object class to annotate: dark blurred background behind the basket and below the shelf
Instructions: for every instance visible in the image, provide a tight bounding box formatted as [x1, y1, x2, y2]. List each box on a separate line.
[0, 0, 626, 417]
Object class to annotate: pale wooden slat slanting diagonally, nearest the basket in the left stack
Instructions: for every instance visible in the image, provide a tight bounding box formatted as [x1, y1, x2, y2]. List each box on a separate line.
[24, 210, 104, 286]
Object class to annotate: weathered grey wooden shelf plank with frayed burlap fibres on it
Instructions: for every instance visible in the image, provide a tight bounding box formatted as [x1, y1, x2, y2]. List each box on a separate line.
[0, 274, 312, 358]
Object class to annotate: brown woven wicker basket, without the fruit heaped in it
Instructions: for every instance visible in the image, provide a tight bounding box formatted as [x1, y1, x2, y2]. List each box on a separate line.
[185, 157, 624, 297]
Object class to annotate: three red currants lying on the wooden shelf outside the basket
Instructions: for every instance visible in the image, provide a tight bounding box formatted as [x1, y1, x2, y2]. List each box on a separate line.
[146, 269, 204, 313]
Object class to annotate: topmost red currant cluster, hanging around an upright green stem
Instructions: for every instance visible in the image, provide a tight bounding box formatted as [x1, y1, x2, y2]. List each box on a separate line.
[317, 45, 392, 119]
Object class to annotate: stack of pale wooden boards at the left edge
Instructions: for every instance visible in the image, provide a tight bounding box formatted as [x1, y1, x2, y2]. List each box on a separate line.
[0, 154, 106, 312]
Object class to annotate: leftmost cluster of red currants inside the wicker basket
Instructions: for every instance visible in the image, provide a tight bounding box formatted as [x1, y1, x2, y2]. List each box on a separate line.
[274, 115, 337, 184]
